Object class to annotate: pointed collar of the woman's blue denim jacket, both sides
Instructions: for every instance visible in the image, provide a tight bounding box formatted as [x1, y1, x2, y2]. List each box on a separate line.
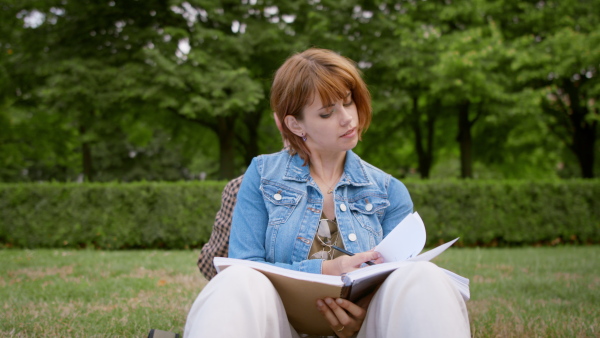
[283, 150, 371, 186]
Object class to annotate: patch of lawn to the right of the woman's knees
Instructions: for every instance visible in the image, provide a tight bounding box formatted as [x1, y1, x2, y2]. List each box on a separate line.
[436, 246, 600, 337]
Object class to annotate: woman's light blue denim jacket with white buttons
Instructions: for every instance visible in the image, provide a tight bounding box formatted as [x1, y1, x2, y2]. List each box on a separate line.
[229, 150, 413, 273]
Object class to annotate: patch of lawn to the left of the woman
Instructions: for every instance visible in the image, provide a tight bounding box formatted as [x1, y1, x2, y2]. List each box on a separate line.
[0, 250, 206, 337]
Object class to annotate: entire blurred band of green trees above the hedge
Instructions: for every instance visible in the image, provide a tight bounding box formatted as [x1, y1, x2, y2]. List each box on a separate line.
[0, 0, 600, 182]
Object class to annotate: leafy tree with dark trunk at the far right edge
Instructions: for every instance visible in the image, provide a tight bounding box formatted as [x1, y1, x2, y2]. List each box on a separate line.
[503, 1, 600, 178]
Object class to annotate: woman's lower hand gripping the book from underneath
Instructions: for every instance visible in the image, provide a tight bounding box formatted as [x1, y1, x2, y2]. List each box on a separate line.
[317, 294, 372, 337]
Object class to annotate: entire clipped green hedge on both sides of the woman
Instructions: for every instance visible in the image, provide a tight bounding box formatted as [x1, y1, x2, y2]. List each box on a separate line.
[0, 180, 600, 249]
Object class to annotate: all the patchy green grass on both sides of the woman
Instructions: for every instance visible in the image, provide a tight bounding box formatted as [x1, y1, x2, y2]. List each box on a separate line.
[0, 246, 600, 337]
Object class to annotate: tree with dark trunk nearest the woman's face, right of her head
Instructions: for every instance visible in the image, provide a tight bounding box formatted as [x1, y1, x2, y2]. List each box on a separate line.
[358, 2, 443, 178]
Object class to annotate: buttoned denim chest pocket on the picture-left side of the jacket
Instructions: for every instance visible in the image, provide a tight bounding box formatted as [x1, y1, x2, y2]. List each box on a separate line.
[260, 179, 304, 226]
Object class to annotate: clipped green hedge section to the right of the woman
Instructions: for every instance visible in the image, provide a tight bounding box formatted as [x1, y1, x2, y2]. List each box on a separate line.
[406, 180, 600, 246]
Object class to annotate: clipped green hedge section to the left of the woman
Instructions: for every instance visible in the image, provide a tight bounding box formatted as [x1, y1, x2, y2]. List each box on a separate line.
[0, 182, 224, 249]
